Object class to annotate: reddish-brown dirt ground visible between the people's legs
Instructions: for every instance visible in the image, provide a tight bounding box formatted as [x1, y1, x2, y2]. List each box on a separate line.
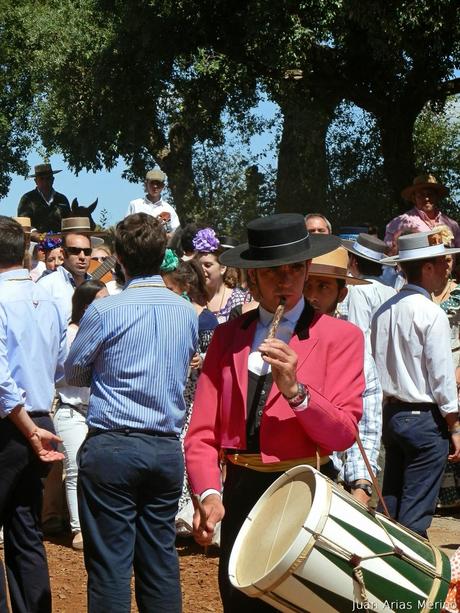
[40, 506, 460, 613]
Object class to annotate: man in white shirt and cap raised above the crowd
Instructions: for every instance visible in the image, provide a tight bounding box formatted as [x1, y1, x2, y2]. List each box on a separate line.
[125, 169, 180, 234]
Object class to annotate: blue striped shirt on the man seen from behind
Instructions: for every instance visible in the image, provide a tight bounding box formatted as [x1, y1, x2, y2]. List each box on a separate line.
[65, 275, 198, 434]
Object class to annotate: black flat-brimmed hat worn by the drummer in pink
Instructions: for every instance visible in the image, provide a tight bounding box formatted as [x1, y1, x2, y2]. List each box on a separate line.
[219, 213, 340, 268]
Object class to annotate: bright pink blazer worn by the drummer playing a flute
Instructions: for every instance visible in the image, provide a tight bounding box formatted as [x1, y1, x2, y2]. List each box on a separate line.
[185, 304, 364, 493]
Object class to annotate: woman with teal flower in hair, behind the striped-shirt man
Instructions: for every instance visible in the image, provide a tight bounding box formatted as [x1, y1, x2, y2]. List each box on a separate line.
[161, 249, 219, 536]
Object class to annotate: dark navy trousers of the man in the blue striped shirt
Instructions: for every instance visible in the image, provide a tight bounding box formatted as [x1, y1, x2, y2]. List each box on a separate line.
[78, 432, 184, 613]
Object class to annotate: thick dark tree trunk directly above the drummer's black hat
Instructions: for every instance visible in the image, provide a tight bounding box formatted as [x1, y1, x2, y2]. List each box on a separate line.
[276, 89, 338, 215]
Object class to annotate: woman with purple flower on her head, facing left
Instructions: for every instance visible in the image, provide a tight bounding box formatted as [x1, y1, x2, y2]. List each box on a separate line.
[193, 228, 247, 324]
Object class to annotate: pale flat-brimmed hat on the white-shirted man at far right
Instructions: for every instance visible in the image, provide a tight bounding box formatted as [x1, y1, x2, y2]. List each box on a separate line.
[382, 230, 460, 264]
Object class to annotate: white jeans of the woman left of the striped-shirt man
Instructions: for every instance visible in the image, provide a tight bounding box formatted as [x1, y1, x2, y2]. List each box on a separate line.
[54, 405, 88, 534]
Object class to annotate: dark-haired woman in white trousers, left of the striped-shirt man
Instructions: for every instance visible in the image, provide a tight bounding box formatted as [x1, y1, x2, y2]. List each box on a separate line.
[54, 280, 109, 549]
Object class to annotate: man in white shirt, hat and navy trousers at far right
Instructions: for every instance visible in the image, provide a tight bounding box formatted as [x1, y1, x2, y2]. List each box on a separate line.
[371, 230, 460, 537]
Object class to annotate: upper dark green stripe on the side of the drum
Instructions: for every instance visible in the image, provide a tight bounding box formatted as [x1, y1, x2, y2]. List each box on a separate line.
[331, 516, 434, 598]
